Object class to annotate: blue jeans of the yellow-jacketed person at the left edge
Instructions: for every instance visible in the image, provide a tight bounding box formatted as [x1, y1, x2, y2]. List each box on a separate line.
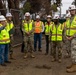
[0, 44, 9, 64]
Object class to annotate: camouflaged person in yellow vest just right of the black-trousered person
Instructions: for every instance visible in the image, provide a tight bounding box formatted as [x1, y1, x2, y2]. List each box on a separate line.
[50, 14, 64, 63]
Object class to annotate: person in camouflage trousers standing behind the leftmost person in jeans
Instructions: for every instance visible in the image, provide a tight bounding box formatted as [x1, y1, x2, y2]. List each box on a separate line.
[6, 13, 14, 59]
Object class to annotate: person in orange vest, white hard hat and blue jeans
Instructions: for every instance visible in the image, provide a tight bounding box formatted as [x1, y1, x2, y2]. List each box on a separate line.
[34, 15, 44, 52]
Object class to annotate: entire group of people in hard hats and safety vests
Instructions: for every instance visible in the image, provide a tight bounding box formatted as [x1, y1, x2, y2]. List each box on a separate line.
[0, 5, 76, 72]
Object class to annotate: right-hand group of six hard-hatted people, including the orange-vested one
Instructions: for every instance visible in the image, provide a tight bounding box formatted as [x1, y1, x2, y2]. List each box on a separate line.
[22, 5, 76, 72]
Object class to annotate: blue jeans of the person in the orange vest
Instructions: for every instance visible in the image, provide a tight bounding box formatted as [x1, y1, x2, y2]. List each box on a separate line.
[34, 33, 42, 50]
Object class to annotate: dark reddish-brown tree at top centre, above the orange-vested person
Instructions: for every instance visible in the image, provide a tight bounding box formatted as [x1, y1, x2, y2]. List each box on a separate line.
[27, 0, 51, 14]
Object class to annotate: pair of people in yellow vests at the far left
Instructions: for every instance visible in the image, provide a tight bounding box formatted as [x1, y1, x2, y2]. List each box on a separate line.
[0, 13, 14, 66]
